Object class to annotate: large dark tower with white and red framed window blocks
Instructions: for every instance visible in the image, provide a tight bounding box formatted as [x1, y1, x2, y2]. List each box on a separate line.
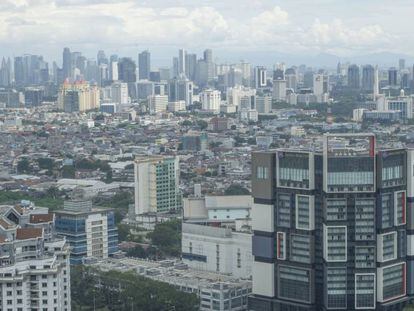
[249, 134, 414, 311]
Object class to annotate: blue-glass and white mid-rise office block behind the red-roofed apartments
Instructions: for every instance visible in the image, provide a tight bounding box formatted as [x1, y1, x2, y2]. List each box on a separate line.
[55, 200, 118, 264]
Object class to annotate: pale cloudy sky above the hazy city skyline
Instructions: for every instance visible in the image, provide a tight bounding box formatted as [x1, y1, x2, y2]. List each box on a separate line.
[0, 0, 414, 62]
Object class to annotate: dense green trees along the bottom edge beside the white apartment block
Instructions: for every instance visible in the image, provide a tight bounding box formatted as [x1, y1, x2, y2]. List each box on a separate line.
[71, 266, 199, 311]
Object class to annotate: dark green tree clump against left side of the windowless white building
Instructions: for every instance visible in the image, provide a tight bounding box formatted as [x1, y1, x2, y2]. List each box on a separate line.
[147, 219, 181, 257]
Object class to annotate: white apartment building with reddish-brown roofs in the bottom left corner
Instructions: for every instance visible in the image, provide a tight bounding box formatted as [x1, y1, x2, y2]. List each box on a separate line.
[0, 205, 71, 311]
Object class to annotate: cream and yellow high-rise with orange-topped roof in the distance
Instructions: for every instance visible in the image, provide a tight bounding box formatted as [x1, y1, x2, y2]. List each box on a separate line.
[58, 81, 99, 112]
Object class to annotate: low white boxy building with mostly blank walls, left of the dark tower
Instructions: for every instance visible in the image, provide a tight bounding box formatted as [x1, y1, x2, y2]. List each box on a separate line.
[181, 223, 253, 279]
